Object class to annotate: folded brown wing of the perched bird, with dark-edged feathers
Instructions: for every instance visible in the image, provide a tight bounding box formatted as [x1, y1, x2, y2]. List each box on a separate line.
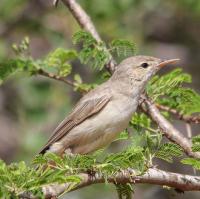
[40, 94, 111, 154]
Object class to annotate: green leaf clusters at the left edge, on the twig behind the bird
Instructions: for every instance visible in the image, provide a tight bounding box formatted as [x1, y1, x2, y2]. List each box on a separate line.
[0, 37, 77, 82]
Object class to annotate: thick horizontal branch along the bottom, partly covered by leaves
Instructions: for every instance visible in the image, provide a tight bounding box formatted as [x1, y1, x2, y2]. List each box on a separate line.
[20, 168, 200, 199]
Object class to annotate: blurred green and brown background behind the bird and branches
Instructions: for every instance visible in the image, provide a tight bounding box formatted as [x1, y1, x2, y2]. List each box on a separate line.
[0, 0, 200, 199]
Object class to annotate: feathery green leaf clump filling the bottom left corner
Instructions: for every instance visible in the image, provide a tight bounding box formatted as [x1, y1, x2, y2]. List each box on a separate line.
[0, 158, 80, 198]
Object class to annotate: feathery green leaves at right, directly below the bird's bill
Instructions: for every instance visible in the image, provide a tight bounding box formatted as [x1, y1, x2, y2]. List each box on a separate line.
[147, 69, 200, 115]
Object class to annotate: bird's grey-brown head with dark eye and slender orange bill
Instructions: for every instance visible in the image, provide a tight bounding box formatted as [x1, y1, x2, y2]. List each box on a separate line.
[111, 55, 179, 84]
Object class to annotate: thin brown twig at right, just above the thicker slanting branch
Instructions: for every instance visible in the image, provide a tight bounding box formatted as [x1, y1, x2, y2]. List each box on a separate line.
[156, 104, 200, 124]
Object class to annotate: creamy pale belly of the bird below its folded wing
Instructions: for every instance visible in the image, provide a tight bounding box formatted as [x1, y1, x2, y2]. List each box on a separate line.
[50, 97, 137, 154]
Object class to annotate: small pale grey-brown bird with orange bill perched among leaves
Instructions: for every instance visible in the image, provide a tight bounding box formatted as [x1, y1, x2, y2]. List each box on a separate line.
[40, 55, 179, 156]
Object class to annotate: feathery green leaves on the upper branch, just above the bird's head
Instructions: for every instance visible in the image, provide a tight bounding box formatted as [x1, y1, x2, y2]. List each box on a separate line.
[73, 30, 135, 70]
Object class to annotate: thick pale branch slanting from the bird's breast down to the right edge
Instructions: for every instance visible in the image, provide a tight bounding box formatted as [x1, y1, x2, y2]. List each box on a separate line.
[140, 96, 200, 158]
